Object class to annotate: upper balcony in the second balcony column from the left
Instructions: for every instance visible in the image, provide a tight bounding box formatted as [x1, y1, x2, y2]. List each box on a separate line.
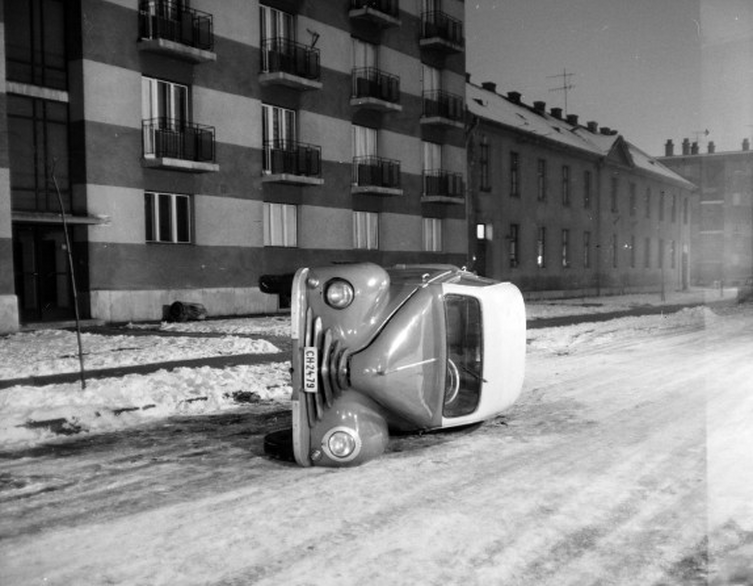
[259, 37, 322, 90]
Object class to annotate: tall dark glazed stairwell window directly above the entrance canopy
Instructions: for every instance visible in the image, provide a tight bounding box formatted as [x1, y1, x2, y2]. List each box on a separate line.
[6, 94, 71, 213]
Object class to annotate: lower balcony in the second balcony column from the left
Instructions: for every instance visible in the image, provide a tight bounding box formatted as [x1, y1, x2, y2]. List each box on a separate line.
[262, 140, 324, 185]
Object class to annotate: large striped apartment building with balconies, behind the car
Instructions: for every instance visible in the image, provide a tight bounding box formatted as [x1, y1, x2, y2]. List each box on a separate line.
[0, 0, 468, 331]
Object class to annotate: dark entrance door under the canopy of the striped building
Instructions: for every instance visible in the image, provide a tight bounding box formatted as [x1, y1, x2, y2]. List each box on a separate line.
[13, 225, 75, 322]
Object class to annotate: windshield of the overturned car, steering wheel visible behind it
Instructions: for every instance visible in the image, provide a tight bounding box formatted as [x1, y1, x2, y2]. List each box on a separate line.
[443, 295, 484, 417]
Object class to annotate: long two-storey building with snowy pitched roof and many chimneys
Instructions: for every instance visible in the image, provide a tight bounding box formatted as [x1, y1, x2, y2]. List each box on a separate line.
[466, 83, 695, 297]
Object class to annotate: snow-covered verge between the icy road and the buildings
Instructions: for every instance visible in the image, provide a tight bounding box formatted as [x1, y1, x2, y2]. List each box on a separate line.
[0, 289, 735, 447]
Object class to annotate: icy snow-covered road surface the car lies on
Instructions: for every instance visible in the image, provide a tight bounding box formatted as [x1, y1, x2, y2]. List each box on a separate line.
[0, 305, 753, 586]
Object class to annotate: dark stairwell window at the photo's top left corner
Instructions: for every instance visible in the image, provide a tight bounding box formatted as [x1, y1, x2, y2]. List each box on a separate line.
[4, 0, 69, 90]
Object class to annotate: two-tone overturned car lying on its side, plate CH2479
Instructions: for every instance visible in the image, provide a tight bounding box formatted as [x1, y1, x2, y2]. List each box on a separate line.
[262, 263, 526, 466]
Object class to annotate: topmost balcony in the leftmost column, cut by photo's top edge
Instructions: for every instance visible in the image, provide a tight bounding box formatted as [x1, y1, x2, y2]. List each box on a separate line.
[139, 0, 217, 63]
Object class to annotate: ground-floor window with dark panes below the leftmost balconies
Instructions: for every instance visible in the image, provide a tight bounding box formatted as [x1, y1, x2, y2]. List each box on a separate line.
[144, 191, 191, 244]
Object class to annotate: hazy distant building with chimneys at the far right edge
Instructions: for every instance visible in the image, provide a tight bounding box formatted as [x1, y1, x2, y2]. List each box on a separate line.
[659, 139, 753, 285]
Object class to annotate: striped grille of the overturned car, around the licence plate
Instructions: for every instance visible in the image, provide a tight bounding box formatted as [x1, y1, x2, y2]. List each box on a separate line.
[303, 307, 350, 425]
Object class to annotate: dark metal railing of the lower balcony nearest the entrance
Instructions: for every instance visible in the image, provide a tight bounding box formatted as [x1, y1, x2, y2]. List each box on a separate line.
[142, 118, 215, 163]
